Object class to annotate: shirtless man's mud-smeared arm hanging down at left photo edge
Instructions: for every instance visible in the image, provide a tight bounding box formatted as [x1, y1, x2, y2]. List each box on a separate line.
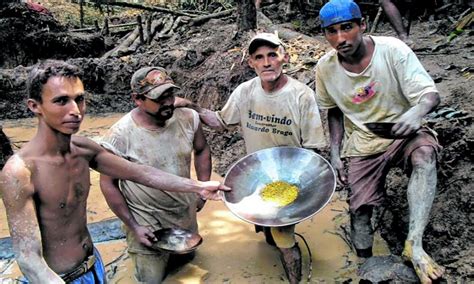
[0, 155, 64, 283]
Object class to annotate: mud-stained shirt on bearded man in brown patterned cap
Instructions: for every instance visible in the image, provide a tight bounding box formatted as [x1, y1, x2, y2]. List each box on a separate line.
[101, 108, 199, 254]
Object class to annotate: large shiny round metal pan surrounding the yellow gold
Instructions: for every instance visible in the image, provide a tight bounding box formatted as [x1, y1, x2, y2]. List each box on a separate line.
[224, 147, 336, 227]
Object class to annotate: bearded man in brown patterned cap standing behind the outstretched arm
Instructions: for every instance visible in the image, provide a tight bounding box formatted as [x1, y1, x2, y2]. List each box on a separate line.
[100, 67, 211, 283]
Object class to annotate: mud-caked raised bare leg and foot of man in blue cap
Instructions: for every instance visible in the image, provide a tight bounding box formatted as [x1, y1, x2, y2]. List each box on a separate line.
[403, 146, 444, 283]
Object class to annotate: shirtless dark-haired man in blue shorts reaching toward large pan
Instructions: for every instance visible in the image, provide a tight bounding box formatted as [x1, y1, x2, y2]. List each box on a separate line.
[0, 61, 228, 283]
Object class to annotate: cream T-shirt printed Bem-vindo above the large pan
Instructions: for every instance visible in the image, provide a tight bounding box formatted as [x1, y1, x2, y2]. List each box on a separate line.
[217, 77, 326, 153]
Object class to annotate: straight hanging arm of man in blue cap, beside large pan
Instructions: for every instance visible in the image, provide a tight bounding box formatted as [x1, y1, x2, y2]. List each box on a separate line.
[328, 107, 347, 185]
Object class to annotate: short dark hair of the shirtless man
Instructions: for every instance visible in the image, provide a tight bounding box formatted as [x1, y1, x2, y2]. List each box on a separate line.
[26, 60, 82, 103]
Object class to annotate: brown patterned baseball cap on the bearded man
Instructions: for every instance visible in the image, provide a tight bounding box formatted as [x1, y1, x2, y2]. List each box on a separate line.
[130, 67, 179, 99]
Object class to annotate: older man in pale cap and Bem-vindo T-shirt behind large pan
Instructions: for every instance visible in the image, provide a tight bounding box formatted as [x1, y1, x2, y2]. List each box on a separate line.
[175, 33, 326, 283]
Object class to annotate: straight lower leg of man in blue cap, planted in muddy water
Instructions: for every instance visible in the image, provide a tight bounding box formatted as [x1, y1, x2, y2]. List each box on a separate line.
[351, 205, 374, 257]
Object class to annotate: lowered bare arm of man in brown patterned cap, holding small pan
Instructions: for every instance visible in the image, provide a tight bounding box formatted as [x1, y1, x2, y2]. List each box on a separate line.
[100, 174, 156, 246]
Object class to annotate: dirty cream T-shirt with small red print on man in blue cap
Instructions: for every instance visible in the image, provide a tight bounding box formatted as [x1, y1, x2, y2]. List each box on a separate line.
[316, 36, 437, 157]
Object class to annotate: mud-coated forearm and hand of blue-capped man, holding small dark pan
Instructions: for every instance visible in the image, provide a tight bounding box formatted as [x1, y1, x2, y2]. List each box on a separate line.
[392, 92, 441, 136]
